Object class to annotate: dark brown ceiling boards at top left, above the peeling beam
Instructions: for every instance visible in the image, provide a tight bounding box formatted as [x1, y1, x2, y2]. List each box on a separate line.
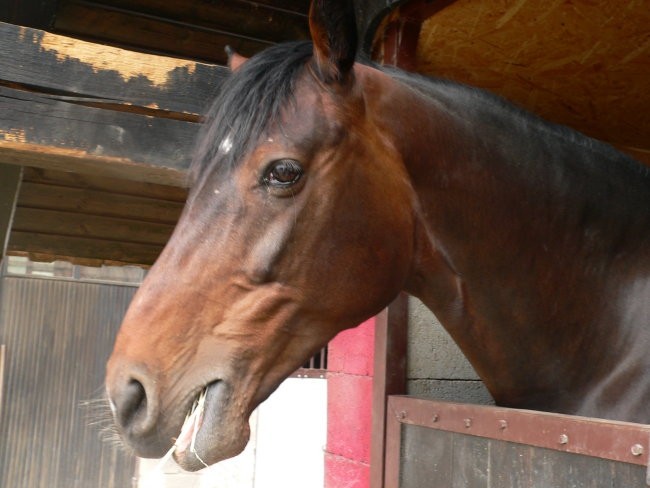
[0, 0, 309, 64]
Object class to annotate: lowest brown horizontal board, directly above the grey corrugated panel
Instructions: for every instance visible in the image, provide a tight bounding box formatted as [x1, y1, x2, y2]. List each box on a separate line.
[7, 231, 162, 266]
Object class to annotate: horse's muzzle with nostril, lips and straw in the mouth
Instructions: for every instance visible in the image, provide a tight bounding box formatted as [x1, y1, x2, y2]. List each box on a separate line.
[106, 358, 250, 471]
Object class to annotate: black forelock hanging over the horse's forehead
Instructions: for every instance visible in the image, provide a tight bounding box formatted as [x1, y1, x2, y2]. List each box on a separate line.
[190, 41, 313, 189]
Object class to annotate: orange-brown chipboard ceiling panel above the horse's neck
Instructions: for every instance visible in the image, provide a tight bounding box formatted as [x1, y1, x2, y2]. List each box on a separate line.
[416, 0, 650, 164]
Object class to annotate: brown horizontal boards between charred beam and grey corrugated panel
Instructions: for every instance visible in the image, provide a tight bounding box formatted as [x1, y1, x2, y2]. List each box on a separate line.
[8, 168, 187, 266]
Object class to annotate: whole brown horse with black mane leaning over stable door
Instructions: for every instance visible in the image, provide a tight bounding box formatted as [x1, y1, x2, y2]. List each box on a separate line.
[107, 1, 650, 469]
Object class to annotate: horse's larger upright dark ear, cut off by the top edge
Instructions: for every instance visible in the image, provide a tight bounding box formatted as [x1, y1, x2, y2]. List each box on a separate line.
[309, 0, 357, 83]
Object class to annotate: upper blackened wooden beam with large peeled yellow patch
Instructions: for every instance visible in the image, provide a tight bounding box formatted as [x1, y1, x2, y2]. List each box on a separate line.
[0, 22, 228, 116]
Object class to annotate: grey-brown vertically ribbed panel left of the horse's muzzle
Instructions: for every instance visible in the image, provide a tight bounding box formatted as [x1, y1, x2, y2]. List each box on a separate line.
[0, 277, 135, 488]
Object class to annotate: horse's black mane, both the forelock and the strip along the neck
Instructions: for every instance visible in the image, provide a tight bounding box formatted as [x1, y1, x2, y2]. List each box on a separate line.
[190, 41, 650, 191]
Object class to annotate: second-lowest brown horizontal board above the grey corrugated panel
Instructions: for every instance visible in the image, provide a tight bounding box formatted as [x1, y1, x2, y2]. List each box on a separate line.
[12, 207, 174, 247]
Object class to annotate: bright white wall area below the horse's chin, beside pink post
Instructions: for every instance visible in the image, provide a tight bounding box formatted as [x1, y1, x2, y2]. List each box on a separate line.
[137, 378, 327, 488]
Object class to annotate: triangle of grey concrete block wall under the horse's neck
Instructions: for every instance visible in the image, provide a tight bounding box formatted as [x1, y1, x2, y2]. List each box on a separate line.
[407, 298, 494, 404]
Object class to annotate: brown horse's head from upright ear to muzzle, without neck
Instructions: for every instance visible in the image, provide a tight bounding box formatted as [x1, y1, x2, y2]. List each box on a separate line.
[106, 1, 413, 470]
